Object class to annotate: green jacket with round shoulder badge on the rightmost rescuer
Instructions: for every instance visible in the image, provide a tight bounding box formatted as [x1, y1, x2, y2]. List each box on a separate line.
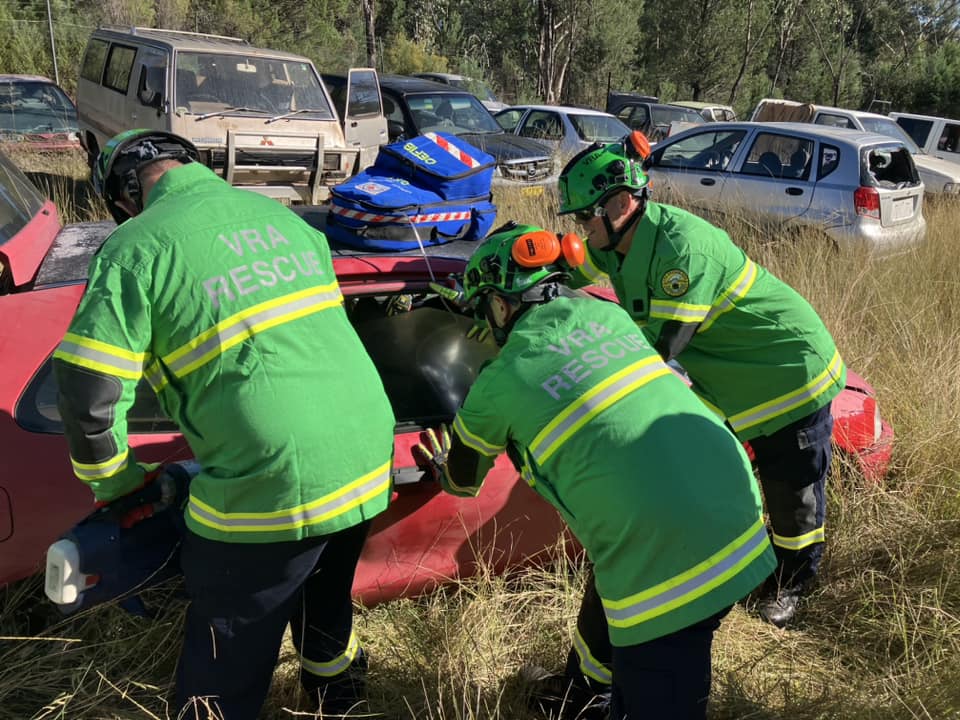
[571, 202, 847, 440]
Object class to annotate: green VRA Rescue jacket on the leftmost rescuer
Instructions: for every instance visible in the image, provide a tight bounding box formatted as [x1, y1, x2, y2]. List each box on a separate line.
[54, 163, 394, 542]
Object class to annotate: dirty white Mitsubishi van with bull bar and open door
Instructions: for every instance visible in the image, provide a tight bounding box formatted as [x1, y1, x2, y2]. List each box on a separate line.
[77, 27, 387, 205]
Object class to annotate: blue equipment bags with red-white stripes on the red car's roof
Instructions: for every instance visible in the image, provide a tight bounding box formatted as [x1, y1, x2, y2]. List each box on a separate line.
[326, 133, 497, 250]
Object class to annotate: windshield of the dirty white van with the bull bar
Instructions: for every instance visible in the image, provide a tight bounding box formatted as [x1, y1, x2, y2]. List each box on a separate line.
[174, 52, 334, 120]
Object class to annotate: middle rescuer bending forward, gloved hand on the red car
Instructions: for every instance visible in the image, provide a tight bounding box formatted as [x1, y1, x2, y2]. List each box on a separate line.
[420, 224, 775, 720]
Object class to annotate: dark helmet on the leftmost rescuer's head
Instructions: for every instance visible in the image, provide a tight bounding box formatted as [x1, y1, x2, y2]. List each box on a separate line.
[91, 128, 200, 225]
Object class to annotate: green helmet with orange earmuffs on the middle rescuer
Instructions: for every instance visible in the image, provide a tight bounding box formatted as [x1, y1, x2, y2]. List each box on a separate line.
[463, 222, 585, 303]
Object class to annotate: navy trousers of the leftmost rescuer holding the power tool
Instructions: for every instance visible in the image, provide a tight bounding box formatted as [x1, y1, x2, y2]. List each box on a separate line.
[176, 521, 370, 720]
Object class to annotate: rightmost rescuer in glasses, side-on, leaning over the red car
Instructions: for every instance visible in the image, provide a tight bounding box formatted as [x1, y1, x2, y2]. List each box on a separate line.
[544, 136, 846, 708]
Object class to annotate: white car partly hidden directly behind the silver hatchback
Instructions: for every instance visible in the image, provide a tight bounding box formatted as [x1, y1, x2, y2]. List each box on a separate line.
[750, 98, 960, 195]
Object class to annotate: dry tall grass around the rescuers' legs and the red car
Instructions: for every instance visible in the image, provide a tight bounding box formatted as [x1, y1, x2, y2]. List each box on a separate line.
[0, 174, 960, 720]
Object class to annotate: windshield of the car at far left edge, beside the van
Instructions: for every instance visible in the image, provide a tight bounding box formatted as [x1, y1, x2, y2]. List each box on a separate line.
[0, 80, 77, 134]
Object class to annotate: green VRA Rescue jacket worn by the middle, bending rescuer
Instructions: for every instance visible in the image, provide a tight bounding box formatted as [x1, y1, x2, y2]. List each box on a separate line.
[443, 298, 775, 646]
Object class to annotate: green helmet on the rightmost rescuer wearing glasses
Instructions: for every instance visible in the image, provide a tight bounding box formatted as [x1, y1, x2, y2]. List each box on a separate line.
[557, 143, 649, 215]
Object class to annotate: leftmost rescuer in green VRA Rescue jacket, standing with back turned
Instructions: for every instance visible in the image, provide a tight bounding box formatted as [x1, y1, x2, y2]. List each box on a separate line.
[54, 130, 394, 720]
